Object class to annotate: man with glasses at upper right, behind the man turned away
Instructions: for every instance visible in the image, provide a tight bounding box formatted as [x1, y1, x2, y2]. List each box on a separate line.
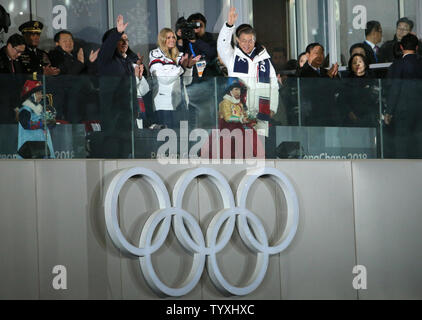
[380, 17, 422, 62]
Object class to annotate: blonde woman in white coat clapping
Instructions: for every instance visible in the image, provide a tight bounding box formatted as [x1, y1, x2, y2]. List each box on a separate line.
[149, 28, 201, 128]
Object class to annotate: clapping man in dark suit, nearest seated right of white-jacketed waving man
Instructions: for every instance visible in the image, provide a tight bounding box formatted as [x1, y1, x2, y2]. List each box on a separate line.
[299, 43, 339, 126]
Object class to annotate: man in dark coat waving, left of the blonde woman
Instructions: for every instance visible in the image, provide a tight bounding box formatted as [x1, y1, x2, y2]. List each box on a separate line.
[95, 15, 139, 159]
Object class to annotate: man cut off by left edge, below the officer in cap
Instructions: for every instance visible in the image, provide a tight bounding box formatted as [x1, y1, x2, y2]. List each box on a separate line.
[0, 34, 25, 123]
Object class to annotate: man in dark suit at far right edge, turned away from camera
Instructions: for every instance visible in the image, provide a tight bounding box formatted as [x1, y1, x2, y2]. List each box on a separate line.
[385, 34, 422, 159]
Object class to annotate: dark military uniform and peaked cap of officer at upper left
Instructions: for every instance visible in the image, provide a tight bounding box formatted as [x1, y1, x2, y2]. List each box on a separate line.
[19, 21, 51, 74]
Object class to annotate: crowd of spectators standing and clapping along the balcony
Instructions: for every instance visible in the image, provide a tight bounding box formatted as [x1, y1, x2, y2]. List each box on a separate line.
[0, 8, 422, 156]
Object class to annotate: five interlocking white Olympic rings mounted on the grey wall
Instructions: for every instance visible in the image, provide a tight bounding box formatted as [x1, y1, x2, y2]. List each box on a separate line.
[104, 167, 299, 297]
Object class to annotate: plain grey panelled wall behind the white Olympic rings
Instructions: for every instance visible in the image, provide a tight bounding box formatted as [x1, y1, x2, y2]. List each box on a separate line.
[0, 160, 422, 300]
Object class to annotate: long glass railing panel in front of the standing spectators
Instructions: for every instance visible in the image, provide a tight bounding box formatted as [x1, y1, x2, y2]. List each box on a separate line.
[0, 75, 422, 159]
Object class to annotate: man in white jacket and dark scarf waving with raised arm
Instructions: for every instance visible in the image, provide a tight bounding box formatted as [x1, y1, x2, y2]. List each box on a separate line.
[217, 8, 279, 136]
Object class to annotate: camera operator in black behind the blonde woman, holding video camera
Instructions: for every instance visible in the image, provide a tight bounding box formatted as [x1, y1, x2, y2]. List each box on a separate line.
[176, 13, 218, 129]
